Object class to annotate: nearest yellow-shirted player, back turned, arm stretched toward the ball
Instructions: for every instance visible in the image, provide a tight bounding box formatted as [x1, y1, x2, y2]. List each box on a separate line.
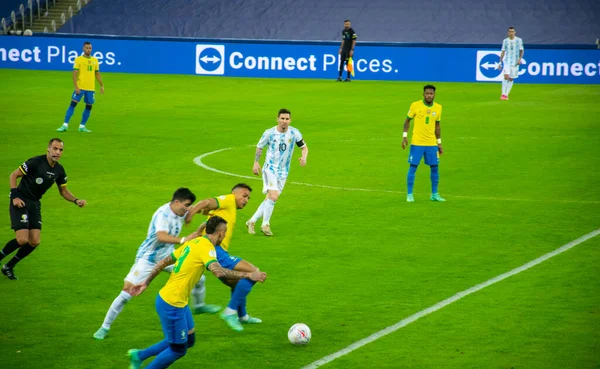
[127, 216, 267, 369]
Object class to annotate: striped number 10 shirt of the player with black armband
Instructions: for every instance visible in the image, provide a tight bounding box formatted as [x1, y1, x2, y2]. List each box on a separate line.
[256, 126, 304, 178]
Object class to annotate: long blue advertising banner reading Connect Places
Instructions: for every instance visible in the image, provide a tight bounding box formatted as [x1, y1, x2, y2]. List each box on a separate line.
[0, 36, 600, 84]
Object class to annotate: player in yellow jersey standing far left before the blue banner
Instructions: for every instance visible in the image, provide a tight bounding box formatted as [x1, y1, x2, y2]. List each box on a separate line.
[57, 42, 104, 132]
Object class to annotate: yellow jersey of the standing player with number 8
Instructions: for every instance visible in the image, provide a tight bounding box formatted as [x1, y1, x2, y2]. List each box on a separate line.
[406, 100, 442, 146]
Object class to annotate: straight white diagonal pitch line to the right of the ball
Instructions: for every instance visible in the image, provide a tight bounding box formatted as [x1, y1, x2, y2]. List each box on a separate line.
[302, 229, 600, 369]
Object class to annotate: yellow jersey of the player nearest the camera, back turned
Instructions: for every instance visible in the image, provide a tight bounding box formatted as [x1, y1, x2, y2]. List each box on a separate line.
[158, 237, 217, 308]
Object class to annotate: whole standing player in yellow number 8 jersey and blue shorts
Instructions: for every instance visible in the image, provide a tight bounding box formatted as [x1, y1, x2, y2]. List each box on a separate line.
[402, 85, 446, 202]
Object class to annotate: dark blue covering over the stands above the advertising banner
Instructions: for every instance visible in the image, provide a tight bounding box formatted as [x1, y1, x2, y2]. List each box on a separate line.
[59, 0, 600, 45]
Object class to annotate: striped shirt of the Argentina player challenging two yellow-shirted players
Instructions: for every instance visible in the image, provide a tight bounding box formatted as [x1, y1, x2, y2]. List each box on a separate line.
[135, 203, 185, 264]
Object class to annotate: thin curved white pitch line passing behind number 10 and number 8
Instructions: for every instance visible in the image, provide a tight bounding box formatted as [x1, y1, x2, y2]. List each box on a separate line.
[194, 145, 600, 204]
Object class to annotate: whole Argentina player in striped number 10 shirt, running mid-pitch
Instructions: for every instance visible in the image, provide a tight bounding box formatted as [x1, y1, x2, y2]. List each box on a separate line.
[246, 109, 308, 236]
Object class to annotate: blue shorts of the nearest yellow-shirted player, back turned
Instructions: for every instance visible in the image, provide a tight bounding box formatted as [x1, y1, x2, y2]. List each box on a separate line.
[156, 295, 194, 344]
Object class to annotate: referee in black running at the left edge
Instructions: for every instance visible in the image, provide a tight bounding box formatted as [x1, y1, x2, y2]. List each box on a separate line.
[0, 138, 86, 279]
